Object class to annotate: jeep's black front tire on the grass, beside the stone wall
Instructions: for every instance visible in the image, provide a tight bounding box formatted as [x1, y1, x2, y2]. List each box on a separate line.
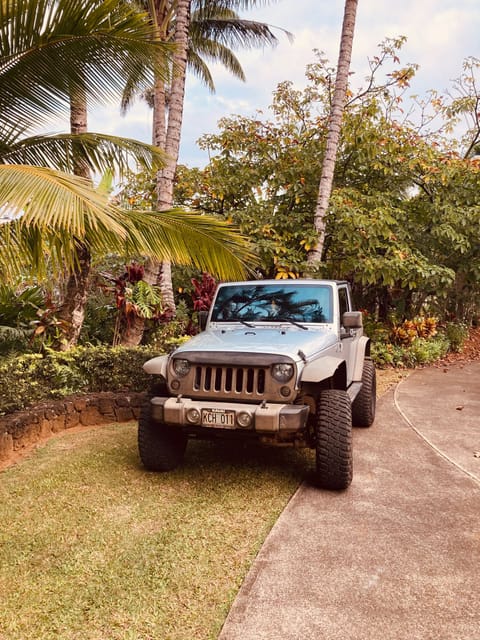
[138, 383, 187, 471]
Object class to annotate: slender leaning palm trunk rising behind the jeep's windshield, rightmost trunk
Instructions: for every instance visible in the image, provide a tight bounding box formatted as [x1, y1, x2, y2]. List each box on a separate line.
[307, 0, 358, 267]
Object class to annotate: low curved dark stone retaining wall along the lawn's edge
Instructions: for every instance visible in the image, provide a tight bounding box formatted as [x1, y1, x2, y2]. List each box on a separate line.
[0, 391, 145, 462]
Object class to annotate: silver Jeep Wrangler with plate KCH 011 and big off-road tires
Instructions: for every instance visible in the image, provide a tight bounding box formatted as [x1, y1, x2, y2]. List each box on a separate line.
[138, 280, 375, 490]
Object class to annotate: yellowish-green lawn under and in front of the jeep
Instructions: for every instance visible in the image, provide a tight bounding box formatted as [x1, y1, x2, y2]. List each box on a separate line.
[0, 423, 311, 640]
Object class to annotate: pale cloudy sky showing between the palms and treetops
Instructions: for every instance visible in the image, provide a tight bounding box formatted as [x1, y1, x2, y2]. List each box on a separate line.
[90, 0, 480, 167]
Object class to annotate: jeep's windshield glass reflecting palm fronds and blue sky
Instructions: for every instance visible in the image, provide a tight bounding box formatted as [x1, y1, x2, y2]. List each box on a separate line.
[212, 284, 332, 322]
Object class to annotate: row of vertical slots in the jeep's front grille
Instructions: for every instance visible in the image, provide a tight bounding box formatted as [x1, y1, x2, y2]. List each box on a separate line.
[194, 366, 267, 396]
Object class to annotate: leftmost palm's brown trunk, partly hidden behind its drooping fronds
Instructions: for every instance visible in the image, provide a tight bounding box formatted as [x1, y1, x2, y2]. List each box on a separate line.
[55, 85, 91, 351]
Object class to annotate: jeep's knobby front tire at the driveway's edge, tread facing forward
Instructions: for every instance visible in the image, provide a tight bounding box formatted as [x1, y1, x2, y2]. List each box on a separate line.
[314, 389, 353, 491]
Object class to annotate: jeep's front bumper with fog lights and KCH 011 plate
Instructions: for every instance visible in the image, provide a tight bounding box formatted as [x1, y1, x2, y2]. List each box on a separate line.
[151, 396, 309, 434]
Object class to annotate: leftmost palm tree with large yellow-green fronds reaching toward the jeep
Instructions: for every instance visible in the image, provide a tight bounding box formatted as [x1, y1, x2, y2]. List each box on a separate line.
[0, 0, 255, 342]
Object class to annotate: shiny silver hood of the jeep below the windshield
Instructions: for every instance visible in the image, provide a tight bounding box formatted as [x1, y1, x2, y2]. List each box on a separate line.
[175, 327, 337, 364]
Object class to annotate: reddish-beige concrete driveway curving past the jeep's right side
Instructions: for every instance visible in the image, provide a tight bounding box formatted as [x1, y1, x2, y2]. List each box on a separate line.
[219, 362, 480, 640]
